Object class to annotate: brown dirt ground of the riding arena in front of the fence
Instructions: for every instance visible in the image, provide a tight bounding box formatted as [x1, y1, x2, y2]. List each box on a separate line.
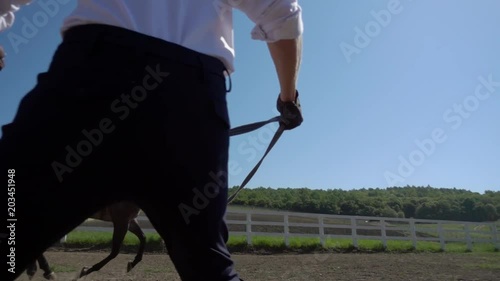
[17, 251, 500, 281]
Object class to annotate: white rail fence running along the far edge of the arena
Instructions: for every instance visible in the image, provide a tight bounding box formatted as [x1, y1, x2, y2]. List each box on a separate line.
[70, 210, 500, 250]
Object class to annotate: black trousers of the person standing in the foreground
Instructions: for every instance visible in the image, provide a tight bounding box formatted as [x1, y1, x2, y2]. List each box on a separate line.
[0, 25, 239, 281]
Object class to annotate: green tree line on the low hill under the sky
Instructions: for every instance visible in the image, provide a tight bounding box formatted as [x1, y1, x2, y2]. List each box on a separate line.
[229, 186, 500, 222]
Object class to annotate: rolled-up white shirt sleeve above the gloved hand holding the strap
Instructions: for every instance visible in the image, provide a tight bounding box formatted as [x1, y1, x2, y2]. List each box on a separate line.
[227, 0, 304, 42]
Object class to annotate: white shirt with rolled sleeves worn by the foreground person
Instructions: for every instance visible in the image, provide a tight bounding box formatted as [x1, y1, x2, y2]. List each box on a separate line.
[0, 0, 303, 72]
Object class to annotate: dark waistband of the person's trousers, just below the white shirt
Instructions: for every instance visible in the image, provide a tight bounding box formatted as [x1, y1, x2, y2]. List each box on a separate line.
[63, 24, 229, 77]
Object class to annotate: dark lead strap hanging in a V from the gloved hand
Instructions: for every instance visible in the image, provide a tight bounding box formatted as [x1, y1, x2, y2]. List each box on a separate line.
[227, 116, 285, 204]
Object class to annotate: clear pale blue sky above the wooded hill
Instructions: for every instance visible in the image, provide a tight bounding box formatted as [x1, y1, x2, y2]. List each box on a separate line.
[0, 0, 500, 192]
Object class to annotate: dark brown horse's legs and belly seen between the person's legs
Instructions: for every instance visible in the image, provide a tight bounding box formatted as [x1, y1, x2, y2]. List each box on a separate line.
[27, 201, 146, 280]
